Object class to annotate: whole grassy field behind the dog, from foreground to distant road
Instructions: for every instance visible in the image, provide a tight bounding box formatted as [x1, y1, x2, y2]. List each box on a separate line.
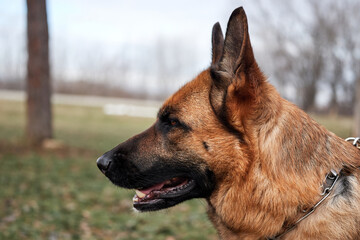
[0, 98, 351, 240]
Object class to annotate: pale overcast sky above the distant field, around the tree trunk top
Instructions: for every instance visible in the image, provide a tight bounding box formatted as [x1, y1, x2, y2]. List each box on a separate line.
[0, 0, 324, 102]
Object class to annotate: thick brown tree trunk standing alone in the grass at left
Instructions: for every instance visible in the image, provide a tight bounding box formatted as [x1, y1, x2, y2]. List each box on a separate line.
[26, 0, 52, 146]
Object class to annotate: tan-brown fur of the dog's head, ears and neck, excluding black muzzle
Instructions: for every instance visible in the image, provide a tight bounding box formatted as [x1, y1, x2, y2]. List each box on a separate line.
[97, 8, 360, 240]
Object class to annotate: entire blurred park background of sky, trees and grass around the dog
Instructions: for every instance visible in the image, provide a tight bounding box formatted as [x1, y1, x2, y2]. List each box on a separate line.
[0, 0, 360, 240]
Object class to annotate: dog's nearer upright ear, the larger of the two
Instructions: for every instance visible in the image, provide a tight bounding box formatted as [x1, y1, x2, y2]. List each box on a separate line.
[210, 7, 264, 117]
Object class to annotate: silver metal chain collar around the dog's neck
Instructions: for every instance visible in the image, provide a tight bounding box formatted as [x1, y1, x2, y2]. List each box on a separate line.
[266, 137, 360, 240]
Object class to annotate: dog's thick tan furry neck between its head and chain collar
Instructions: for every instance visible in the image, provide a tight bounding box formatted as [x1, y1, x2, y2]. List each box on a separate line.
[205, 89, 360, 239]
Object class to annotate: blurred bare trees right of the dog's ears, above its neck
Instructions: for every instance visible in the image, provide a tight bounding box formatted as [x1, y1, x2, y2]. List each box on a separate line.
[253, 0, 360, 114]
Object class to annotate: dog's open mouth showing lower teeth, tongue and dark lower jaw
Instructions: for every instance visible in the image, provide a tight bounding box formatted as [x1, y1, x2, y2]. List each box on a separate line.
[133, 177, 196, 211]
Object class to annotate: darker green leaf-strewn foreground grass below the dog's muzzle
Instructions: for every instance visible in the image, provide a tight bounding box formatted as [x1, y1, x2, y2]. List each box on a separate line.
[0, 153, 214, 239]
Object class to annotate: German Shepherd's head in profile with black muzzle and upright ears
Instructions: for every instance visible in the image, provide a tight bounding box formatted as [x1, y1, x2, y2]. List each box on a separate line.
[97, 8, 270, 211]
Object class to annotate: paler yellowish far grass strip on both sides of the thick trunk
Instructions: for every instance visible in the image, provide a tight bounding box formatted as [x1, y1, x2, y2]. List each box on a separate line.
[0, 101, 154, 152]
